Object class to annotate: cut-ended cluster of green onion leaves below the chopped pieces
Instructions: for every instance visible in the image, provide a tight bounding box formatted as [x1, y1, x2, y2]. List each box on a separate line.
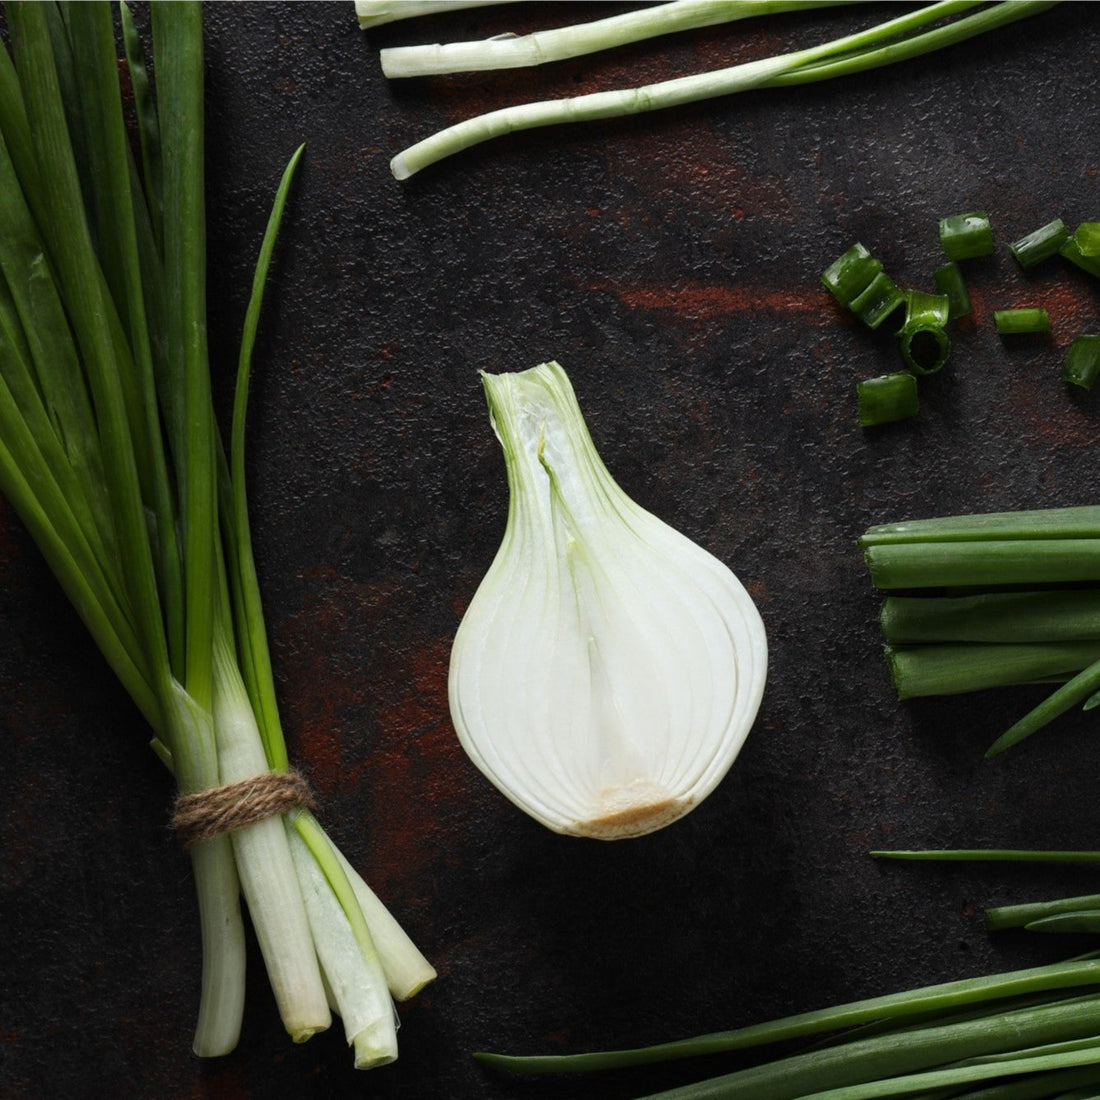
[860, 505, 1100, 756]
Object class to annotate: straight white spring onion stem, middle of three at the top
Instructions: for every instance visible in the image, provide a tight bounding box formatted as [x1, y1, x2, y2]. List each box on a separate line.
[380, 0, 845, 79]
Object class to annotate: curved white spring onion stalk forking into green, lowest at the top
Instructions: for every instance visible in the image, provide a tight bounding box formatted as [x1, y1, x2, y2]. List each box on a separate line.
[391, 0, 1052, 179]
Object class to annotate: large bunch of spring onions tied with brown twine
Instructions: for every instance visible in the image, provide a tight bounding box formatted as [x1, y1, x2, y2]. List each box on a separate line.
[0, 2, 433, 1067]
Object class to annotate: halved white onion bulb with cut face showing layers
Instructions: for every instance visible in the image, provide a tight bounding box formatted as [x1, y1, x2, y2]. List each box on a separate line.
[449, 363, 768, 840]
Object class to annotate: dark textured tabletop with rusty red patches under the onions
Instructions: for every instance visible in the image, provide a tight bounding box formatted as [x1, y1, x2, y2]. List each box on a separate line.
[0, 3, 1100, 1100]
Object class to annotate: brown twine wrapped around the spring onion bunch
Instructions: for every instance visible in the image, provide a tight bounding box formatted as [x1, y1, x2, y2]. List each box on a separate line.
[172, 771, 316, 848]
